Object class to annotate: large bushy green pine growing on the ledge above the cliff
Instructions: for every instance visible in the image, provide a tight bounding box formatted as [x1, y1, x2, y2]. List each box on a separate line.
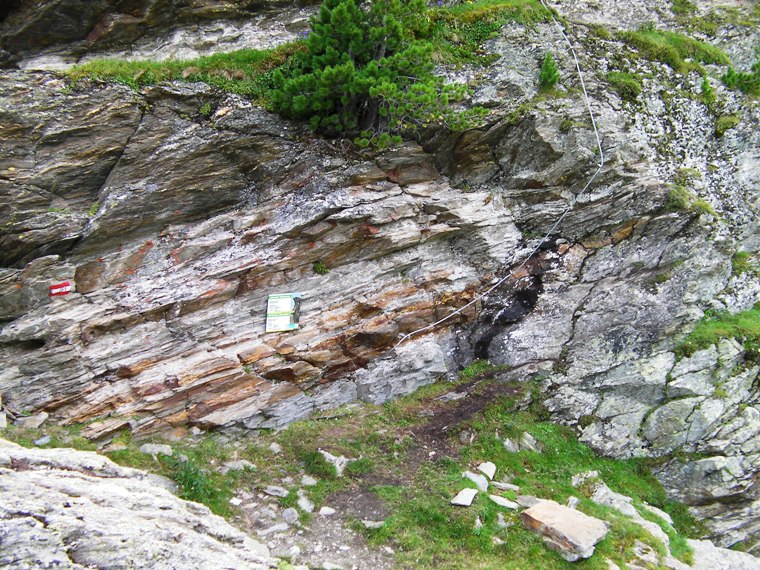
[272, 0, 483, 146]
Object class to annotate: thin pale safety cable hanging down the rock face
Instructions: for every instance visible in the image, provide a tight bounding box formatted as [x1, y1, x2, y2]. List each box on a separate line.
[393, 0, 605, 349]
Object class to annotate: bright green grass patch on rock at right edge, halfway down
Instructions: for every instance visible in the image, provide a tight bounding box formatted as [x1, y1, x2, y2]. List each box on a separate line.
[676, 303, 760, 360]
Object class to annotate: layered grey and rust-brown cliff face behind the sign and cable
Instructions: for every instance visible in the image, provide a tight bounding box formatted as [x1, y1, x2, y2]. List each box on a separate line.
[0, 2, 760, 549]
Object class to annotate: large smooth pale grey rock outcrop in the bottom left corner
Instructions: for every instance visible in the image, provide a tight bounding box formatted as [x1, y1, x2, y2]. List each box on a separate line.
[0, 439, 277, 570]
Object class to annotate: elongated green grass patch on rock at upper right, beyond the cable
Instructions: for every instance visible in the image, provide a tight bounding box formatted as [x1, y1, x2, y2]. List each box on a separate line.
[619, 26, 731, 74]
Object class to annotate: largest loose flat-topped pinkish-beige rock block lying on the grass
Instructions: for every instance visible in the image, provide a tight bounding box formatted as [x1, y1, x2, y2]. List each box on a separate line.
[520, 500, 609, 562]
